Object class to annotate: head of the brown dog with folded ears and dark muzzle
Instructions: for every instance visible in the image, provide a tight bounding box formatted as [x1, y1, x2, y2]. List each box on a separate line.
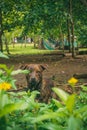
[20, 64, 47, 91]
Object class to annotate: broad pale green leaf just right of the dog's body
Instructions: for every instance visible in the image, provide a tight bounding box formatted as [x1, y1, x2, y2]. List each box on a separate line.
[52, 87, 69, 103]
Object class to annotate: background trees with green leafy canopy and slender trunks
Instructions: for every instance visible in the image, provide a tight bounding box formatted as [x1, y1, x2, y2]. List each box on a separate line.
[0, 0, 87, 57]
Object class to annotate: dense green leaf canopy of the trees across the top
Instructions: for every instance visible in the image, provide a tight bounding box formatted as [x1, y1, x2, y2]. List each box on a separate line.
[0, 0, 87, 51]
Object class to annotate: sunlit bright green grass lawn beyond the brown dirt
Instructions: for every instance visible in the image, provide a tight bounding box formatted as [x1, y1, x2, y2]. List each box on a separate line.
[4, 44, 59, 55]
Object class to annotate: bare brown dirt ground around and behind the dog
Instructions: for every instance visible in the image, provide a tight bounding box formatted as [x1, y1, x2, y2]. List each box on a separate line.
[0, 54, 87, 92]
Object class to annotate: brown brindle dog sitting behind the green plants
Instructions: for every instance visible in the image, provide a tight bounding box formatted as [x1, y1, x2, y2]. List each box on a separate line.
[20, 64, 54, 103]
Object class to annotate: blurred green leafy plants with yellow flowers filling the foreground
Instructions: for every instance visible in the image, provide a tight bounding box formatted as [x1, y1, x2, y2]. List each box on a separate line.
[0, 53, 87, 130]
